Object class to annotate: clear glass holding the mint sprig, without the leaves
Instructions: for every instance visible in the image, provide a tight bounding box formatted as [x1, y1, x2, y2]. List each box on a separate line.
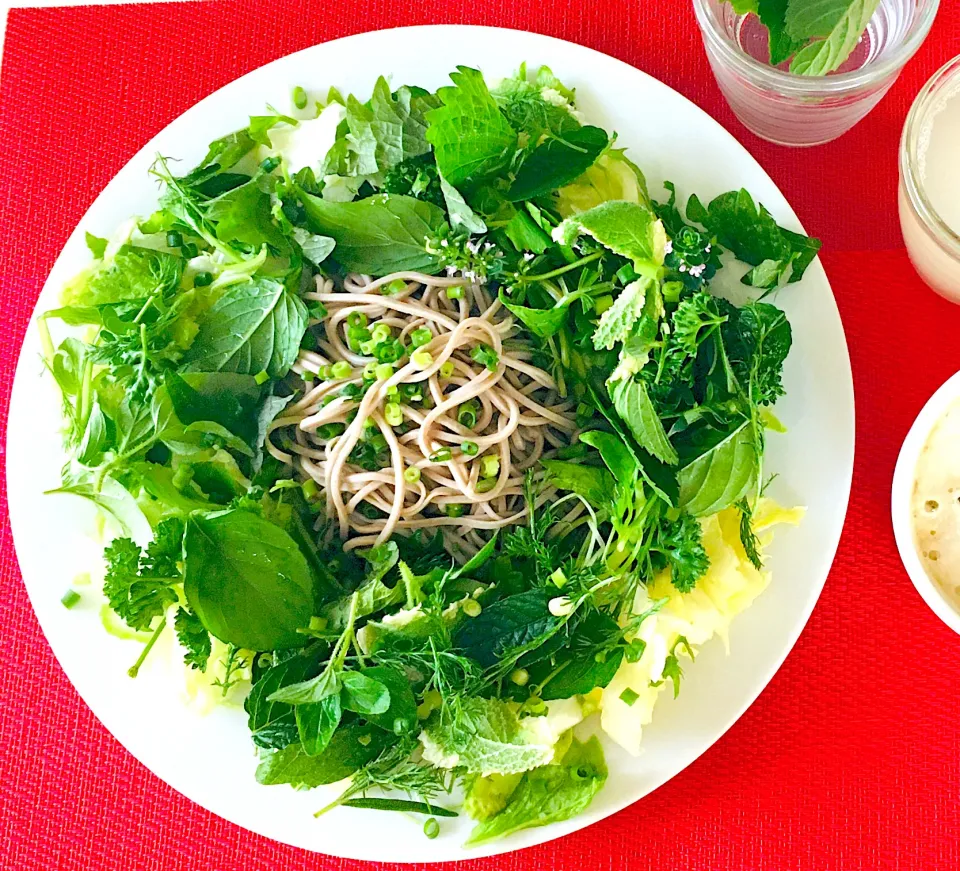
[693, 0, 940, 146]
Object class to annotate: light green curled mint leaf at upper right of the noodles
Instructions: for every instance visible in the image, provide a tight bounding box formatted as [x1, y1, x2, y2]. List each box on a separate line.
[553, 200, 667, 278]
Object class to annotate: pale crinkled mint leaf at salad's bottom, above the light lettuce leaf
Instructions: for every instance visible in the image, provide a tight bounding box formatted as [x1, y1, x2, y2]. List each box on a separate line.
[421, 698, 553, 775]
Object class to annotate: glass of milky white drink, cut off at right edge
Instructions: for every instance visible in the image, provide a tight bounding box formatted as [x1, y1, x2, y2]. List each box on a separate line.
[900, 57, 960, 303]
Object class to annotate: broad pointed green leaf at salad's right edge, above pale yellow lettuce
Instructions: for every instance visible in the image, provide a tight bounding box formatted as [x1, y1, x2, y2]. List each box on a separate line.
[678, 421, 757, 517]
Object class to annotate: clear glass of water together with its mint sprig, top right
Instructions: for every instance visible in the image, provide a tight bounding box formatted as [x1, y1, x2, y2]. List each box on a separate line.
[694, 0, 939, 146]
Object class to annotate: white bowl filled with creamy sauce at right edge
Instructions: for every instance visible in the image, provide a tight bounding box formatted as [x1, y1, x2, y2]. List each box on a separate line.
[891, 372, 960, 634]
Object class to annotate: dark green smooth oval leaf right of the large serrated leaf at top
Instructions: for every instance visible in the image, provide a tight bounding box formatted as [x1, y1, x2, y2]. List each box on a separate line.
[509, 127, 609, 202]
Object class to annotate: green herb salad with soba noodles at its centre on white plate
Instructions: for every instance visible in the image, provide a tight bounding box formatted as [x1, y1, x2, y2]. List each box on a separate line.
[40, 67, 819, 844]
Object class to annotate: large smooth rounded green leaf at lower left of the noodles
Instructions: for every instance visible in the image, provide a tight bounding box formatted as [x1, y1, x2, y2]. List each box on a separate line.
[183, 509, 313, 650]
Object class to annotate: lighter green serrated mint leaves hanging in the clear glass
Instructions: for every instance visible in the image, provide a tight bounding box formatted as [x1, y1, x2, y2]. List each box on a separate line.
[786, 0, 880, 76]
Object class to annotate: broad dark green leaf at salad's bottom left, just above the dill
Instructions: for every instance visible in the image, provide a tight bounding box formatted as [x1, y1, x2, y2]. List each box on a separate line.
[257, 723, 391, 789]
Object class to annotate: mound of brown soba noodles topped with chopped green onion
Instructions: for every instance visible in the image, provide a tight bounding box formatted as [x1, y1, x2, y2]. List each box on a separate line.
[267, 272, 576, 554]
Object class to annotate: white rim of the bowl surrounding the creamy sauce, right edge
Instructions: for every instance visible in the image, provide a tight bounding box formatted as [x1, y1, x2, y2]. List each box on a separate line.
[890, 372, 960, 635]
